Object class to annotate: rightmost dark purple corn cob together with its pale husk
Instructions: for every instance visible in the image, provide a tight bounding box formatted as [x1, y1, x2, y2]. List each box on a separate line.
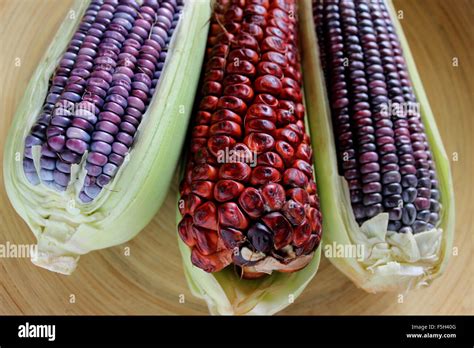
[302, 0, 454, 292]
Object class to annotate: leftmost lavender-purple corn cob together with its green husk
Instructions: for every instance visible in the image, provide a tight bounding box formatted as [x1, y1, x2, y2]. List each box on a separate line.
[4, 0, 209, 274]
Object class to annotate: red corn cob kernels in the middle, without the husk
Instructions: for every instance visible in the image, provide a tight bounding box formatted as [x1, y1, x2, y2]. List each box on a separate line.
[178, 1, 321, 278]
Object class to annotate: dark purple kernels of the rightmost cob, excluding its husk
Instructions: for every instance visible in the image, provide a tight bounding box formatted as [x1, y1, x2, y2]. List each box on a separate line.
[313, 0, 440, 233]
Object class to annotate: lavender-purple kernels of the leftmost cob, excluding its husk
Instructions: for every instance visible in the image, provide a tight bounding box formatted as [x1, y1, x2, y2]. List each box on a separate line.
[24, 0, 183, 202]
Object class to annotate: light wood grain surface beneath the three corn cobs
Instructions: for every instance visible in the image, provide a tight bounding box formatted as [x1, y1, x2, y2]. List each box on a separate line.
[0, 0, 474, 315]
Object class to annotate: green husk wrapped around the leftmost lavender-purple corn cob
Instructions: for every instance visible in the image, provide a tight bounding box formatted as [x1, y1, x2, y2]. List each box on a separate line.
[3, 0, 211, 274]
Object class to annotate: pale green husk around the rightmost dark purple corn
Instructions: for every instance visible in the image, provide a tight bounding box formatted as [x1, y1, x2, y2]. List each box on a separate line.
[300, 0, 455, 292]
